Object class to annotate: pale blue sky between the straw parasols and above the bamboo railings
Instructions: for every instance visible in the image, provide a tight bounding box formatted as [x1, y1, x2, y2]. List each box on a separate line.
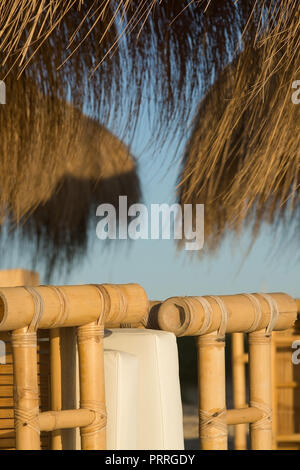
[2, 103, 300, 299]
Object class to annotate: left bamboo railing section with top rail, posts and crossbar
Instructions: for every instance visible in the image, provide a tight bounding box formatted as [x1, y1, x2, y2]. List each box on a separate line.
[0, 284, 149, 450]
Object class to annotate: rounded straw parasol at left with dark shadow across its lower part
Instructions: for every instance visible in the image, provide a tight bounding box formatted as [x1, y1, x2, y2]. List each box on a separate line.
[0, 79, 140, 275]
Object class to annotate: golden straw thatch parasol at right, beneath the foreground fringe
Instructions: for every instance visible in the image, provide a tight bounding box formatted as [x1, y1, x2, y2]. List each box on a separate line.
[179, 38, 300, 248]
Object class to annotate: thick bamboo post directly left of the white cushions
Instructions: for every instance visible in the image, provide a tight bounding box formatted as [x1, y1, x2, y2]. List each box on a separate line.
[77, 322, 106, 450]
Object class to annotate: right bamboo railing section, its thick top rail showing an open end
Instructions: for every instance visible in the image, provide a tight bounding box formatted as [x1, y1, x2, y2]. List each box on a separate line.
[158, 293, 297, 450]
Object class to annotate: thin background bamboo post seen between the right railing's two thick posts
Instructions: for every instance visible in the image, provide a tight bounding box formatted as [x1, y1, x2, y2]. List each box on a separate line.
[231, 333, 247, 450]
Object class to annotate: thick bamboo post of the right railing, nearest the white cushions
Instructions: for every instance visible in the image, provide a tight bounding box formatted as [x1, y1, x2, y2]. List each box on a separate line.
[197, 332, 227, 450]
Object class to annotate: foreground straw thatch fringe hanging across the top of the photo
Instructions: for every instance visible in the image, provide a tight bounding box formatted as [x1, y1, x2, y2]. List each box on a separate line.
[0, 0, 299, 142]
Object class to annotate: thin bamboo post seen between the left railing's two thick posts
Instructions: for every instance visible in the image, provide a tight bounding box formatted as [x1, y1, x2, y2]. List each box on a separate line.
[50, 328, 63, 450]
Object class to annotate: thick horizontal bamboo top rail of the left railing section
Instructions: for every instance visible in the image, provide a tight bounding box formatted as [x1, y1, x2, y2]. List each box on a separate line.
[0, 284, 149, 331]
